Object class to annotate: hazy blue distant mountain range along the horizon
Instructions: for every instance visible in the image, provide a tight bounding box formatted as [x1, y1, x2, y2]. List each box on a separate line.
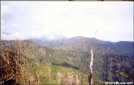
[29, 36, 134, 57]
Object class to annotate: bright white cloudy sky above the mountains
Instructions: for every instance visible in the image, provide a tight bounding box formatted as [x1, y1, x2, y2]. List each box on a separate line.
[1, 1, 134, 42]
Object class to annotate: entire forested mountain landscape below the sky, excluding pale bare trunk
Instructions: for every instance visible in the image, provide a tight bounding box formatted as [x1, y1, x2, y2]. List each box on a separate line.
[0, 36, 134, 84]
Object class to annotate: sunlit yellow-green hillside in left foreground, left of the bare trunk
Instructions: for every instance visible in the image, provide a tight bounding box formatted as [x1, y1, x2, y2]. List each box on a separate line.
[0, 41, 87, 85]
